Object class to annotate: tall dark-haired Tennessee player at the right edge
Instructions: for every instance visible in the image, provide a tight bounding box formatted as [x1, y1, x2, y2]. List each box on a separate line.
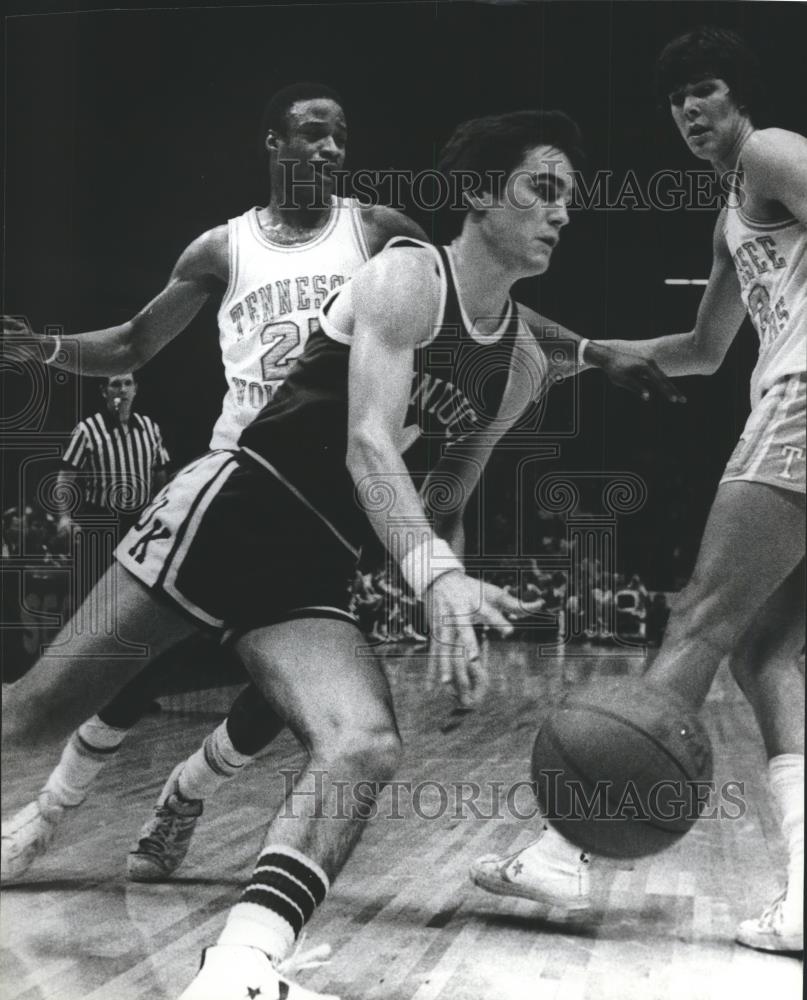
[471, 27, 807, 951]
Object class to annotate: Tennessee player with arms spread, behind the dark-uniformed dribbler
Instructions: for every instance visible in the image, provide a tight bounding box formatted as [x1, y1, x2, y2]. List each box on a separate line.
[2, 83, 425, 881]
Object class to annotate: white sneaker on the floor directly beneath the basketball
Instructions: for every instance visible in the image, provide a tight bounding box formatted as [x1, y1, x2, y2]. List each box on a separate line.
[469, 831, 591, 912]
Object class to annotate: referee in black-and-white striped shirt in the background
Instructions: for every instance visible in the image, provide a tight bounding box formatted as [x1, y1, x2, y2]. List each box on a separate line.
[58, 373, 169, 536]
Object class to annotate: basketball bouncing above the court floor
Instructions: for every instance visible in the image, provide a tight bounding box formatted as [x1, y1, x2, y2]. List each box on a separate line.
[532, 677, 712, 858]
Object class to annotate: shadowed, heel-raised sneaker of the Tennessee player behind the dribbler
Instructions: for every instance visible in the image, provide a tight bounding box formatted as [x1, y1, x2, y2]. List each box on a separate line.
[126, 761, 203, 882]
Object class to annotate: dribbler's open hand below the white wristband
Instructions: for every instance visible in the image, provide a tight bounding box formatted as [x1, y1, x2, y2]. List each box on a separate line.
[424, 570, 520, 708]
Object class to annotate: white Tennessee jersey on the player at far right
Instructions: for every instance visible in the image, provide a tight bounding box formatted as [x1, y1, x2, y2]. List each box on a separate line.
[725, 198, 807, 406]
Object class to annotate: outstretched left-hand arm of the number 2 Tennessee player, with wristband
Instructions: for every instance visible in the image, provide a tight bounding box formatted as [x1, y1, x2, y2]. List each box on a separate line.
[3, 226, 228, 375]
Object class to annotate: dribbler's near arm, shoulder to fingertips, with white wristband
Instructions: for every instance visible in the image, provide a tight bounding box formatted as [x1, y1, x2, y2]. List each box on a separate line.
[344, 249, 518, 706]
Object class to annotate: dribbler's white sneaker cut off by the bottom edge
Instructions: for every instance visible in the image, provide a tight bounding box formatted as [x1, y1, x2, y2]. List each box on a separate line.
[179, 944, 339, 1000]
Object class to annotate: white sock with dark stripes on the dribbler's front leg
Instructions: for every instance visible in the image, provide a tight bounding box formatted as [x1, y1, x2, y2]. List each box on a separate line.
[218, 844, 330, 961]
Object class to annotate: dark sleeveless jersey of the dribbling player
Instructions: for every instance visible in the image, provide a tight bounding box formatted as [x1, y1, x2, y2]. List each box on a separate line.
[239, 238, 518, 549]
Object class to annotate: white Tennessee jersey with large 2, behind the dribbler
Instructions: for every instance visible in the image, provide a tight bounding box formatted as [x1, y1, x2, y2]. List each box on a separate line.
[210, 197, 370, 448]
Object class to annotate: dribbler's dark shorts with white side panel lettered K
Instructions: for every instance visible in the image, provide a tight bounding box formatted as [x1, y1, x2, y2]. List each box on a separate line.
[115, 451, 356, 632]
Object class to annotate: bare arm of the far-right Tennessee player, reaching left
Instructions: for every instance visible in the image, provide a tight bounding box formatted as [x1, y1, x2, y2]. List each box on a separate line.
[586, 209, 745, 376]
